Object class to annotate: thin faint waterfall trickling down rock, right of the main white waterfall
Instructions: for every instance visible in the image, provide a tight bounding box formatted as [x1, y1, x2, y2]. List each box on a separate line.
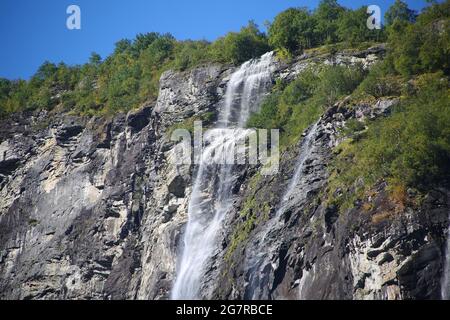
[244, 121, 319, 299]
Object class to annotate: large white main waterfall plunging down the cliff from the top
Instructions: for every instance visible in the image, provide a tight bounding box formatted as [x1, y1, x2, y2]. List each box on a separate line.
[172, 53, 273, 299]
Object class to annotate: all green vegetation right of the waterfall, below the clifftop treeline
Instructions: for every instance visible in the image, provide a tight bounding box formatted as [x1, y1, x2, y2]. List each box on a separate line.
[248, 1, 450, 212]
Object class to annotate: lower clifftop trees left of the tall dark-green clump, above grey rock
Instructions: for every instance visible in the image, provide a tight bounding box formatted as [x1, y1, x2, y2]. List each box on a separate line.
[0, 22, 270, 116]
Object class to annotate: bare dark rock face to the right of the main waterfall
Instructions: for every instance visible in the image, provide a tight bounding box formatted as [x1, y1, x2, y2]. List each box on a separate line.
[216, 99, 450, 299]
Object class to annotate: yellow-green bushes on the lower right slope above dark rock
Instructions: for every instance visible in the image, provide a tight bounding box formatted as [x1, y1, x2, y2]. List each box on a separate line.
[329, 72, 450, 210]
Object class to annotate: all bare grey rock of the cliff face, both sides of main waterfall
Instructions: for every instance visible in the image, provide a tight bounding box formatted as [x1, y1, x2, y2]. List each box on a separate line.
[0, 48, 450, 299]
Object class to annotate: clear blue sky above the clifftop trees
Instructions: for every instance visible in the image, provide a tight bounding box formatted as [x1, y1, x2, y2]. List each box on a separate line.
[0, 0, 426, 79]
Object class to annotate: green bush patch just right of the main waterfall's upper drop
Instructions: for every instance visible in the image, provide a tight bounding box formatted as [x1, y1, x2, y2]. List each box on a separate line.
[247, 66, 364, 147]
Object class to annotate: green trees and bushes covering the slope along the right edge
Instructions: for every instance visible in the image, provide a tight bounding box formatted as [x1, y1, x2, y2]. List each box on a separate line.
[329, 1, 450, 206]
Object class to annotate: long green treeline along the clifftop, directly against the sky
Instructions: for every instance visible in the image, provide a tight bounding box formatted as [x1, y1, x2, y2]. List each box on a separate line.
[0, 0, 392, 116]
